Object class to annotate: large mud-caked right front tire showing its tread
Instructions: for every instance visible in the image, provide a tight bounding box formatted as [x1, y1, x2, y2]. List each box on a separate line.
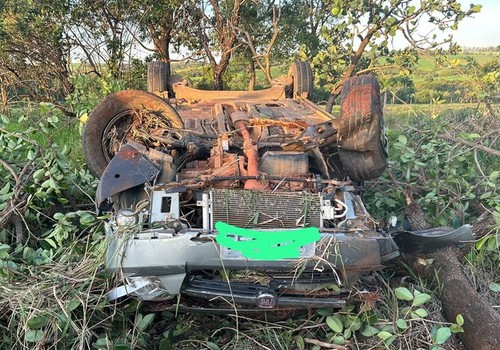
[338, 75, 387, 181]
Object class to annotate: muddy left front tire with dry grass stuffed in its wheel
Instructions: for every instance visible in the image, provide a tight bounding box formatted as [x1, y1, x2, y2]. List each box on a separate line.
[83, 90, 184, 177]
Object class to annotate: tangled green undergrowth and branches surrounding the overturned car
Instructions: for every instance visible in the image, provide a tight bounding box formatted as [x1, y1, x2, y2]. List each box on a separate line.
[0, 105, 500, 350]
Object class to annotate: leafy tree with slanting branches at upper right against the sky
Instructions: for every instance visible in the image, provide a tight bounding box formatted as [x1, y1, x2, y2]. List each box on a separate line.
[313, 0, 481, 111]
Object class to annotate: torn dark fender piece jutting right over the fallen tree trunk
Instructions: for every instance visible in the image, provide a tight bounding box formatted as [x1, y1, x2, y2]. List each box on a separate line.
[393, 225, 475, 254]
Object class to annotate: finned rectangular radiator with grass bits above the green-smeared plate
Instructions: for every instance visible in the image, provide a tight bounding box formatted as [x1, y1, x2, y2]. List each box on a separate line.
[211, 189, 321, 229]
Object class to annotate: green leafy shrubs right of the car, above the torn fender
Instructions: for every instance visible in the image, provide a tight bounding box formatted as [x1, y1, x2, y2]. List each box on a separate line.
[366, 108, 500, 226]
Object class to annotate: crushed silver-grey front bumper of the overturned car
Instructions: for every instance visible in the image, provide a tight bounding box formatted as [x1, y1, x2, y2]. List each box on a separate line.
[107, 230, 399, 307]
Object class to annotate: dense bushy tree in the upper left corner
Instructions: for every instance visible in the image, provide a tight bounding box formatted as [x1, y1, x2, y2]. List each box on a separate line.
[0, 0, 72, 101]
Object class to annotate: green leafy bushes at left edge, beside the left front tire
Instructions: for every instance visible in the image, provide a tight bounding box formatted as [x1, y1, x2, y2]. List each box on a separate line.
[0, 104, 94, 245]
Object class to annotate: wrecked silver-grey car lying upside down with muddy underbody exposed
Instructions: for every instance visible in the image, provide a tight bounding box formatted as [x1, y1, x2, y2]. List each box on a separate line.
[83, 62, 473, 309]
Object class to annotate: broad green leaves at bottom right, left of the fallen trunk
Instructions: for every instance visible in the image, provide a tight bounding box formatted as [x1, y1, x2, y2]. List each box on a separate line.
[282, 287, 463, 349]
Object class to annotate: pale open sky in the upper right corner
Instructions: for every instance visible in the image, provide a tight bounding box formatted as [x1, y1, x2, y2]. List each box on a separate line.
[453, 0, 500, 47]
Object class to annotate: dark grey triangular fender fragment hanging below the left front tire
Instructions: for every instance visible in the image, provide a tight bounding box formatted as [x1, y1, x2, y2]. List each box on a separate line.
[96, 143, 160, 209]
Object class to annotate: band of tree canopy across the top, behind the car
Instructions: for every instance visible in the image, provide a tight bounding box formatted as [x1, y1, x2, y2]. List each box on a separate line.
[0, 0, 484, 101]
